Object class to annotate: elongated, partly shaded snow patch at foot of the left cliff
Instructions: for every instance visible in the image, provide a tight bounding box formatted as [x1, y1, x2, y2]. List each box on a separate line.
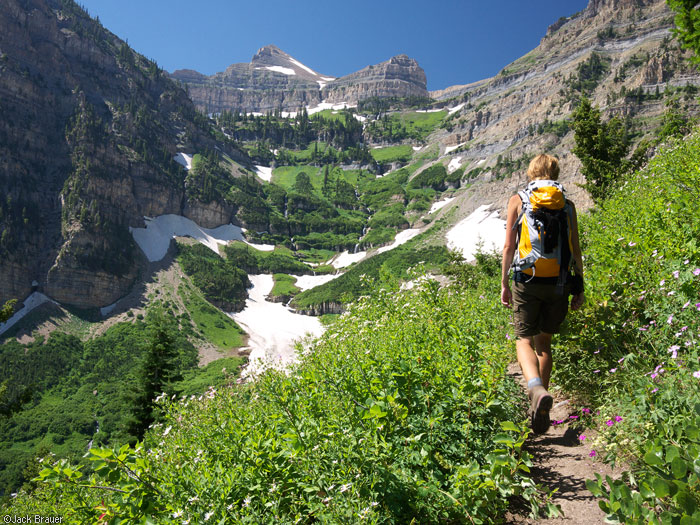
[129, 215, 245, 262]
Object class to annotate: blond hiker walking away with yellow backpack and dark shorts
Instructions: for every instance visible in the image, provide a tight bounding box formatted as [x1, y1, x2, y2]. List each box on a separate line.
[501, 155, 584, 434]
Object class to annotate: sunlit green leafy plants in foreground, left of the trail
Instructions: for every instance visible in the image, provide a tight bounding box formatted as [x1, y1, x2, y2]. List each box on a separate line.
[19, 272, 556, 523]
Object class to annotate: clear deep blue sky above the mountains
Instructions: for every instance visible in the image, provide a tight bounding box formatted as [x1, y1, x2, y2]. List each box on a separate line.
[78, 0, 588, 90]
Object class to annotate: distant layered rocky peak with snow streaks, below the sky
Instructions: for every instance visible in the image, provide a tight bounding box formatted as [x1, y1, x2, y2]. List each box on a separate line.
[171, 45, 428, 113]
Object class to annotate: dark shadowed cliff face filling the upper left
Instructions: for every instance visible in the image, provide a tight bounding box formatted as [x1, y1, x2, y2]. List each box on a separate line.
[0, 0, 247, 307]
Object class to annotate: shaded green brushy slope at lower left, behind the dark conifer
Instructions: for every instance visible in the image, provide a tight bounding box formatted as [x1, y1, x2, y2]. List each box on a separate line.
[0, 321, 197, 494]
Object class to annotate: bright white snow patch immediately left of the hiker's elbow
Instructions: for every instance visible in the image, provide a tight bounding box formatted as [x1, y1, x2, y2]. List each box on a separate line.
[446, 204, 506, 261]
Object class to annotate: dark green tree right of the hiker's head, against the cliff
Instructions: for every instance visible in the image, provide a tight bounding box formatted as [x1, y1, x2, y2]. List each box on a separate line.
[572, 98, 629, 202]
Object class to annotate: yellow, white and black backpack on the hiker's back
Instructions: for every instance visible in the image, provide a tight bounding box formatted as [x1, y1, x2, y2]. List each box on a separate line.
[512, 180, 573, 293]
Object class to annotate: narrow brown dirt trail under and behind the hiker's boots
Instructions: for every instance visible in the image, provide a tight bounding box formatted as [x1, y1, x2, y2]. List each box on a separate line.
[506, 363, 613, 525]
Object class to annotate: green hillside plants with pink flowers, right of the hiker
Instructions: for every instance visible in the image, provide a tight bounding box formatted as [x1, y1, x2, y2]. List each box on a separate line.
[555, 134, 700, 523]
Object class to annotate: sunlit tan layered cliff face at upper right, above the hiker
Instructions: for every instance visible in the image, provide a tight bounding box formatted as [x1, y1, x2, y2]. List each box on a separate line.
[430, 0, 700, 213]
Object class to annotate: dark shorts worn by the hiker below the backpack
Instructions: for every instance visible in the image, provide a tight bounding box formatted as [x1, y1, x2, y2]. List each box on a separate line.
[513, 282, 569, 338]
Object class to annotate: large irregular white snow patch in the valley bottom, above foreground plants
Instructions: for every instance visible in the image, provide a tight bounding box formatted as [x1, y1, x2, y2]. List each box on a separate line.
[234, 275, 323, 377]
